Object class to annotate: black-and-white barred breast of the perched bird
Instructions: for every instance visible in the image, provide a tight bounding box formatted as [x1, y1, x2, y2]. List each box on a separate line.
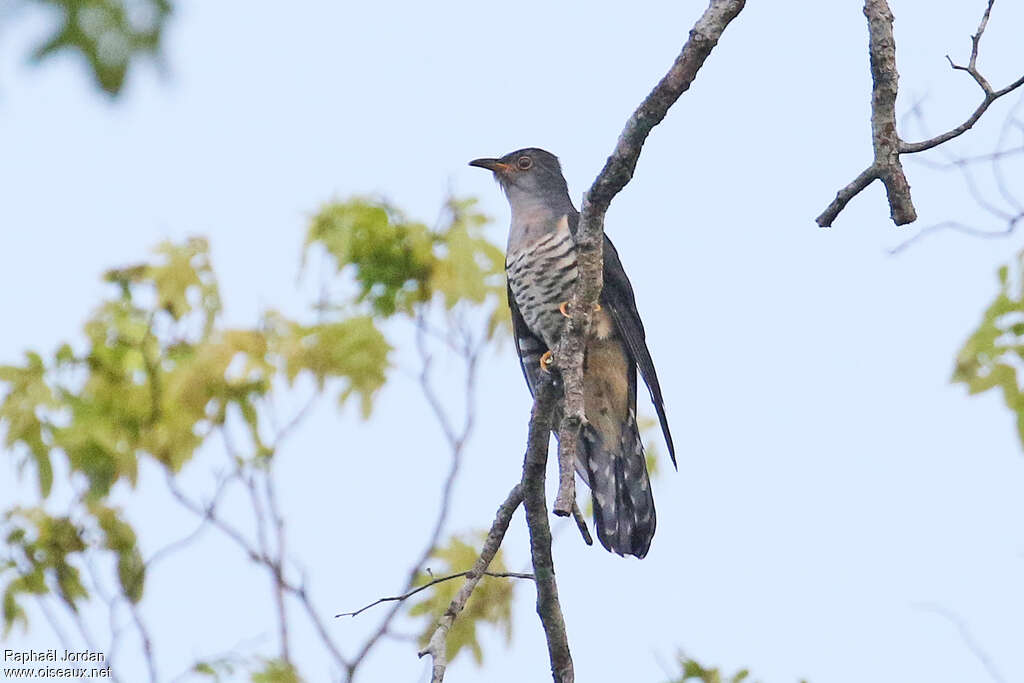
[505, 217, 577, 349]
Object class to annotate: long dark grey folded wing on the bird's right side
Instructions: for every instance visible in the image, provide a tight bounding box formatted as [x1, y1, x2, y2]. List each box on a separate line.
[569, 212, 678, 467]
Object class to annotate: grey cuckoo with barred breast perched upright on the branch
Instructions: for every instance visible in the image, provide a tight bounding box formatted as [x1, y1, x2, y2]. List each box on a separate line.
[469, 147, 676, 558]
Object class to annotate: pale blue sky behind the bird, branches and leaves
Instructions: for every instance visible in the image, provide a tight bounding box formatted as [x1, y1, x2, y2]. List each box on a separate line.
[0, 0, 1024, 683]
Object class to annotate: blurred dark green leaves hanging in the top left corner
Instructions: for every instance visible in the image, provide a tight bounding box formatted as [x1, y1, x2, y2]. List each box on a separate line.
[33, 0, 171, 95]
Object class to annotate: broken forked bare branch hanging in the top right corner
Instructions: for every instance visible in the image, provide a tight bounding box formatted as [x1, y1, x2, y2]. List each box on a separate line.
[816, 0, 1024, 227]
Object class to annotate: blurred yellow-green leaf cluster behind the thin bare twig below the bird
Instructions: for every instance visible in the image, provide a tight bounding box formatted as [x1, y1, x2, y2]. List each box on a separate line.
[409, 532, 515, 665]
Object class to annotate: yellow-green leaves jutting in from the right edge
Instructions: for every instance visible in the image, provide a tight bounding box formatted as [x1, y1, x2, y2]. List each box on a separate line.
[952, 252, 1024, 444]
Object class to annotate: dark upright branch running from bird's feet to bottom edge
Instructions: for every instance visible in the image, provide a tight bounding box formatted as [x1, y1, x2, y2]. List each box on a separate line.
[522, 382, 574, 683]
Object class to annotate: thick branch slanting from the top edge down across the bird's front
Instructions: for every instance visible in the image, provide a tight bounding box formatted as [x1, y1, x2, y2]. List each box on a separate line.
[554, 0, 745, 516]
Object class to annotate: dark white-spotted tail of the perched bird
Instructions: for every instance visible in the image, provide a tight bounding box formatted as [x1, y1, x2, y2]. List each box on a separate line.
[580, 415, 656, 558]
